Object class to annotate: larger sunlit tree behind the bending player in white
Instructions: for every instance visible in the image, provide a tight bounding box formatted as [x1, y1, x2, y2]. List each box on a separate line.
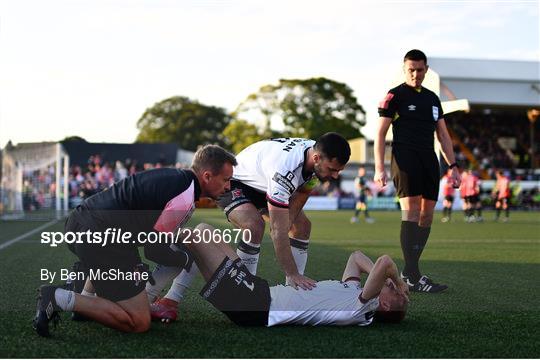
[234, 77, 365, 139]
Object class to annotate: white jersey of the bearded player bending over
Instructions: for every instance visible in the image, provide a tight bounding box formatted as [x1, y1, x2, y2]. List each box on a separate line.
[233, 138, 315, 207]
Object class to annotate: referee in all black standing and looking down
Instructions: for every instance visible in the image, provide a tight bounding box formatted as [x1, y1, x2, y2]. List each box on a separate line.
[374, 49, 461, 293]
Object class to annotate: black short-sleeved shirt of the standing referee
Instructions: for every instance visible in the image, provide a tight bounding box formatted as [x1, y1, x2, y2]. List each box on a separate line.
[379, 83, 444, 150]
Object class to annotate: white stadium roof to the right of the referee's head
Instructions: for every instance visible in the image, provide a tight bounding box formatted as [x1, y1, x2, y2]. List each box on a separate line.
[428, 58, 540, 107]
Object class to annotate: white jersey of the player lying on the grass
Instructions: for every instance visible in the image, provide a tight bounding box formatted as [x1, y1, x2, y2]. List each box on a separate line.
[268, 280, 379, 326]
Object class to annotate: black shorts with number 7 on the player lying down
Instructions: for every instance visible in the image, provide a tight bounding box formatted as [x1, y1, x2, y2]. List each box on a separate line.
[200, 257, 270, 326]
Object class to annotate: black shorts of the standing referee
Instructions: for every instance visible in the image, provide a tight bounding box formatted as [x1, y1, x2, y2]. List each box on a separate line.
[391, 144, 440, 201]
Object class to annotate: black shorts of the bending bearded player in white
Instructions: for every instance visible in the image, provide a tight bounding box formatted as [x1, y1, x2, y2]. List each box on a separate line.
[217, 180, 268, 219]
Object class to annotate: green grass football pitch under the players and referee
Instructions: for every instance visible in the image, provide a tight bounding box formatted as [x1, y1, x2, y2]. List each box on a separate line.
[0, 210, 540, 358]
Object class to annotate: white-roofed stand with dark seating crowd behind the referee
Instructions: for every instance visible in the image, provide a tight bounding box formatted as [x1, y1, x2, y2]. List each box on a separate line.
[430, 58, 540, 180]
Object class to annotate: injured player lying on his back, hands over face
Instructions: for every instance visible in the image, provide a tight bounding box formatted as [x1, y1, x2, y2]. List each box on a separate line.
[189, 224, 409, 326]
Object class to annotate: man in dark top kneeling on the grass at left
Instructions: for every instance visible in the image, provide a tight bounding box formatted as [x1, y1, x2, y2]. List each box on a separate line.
[33, 145, 237, 336]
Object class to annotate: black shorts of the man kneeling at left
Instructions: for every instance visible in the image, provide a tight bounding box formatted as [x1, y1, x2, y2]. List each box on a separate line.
[64, 216, 146, 302]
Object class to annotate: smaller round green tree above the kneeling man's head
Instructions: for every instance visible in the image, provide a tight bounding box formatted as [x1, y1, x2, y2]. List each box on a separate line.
[136, 96, 231, 151]
